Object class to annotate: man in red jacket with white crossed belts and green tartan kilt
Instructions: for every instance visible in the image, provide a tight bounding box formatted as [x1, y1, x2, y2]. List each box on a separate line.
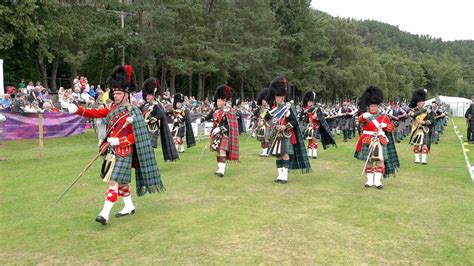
[354, 86, 400, 189]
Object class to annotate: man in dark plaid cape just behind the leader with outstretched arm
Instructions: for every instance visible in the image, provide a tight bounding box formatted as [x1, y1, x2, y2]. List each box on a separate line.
[142, 78, 179, 162]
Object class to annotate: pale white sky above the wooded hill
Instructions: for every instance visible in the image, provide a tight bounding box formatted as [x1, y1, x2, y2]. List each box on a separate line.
[311, 0, 474, 41]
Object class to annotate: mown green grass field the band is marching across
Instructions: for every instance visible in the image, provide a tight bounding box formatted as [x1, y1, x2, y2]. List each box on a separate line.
[0, 119, 474, 264]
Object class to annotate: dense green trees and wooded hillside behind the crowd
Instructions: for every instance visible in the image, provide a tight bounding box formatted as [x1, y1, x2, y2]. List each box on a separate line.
[0, 0, 474, 102]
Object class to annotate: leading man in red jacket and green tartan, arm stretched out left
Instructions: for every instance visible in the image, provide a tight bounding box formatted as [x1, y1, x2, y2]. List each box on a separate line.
[63, 65, 164, 225]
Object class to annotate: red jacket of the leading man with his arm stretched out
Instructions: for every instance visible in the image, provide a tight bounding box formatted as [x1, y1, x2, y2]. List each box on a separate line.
[76, 106, 135, 158]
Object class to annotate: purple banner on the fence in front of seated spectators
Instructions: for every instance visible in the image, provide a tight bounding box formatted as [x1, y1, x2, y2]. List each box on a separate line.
[0, 112, 86, 140]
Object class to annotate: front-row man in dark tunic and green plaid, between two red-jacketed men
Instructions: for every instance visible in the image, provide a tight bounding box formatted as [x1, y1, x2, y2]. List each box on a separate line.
[268, 76, 311, 184]
